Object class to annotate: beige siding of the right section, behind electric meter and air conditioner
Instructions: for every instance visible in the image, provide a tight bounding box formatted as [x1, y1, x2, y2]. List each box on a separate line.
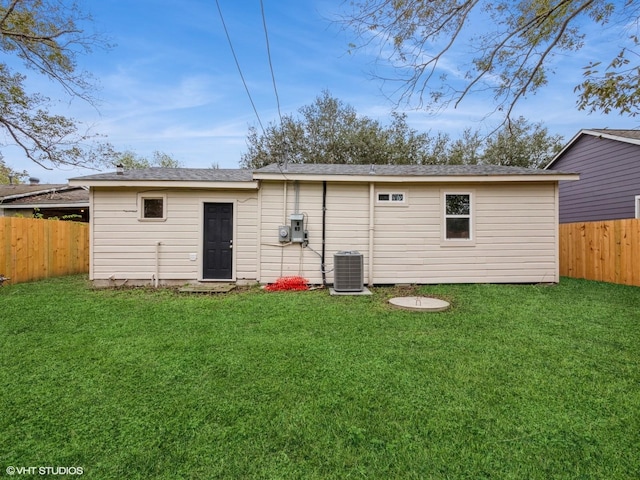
[260, 181, 558, 284]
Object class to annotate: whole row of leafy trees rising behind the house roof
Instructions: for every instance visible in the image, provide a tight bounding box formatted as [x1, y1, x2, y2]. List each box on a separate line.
[240, 92, 563, 169]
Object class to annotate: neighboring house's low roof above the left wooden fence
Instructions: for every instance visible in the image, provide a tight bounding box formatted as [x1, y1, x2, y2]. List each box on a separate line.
[0, 184, 89, 208]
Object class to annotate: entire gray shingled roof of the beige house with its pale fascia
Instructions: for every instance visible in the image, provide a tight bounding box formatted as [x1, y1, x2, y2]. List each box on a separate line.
[69, 164, 578, 188]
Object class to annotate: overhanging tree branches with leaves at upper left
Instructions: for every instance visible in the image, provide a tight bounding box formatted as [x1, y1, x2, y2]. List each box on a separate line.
[0, 0, 111, 169]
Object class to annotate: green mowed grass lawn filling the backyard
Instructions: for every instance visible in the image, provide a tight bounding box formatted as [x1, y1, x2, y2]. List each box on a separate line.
[0, 277, 640, 480]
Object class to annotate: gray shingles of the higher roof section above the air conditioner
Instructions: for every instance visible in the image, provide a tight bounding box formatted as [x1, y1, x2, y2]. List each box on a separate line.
[255, 163, 561, 176]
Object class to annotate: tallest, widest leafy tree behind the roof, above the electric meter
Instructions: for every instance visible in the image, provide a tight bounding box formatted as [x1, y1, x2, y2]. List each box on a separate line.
[240, 91, 431, 168]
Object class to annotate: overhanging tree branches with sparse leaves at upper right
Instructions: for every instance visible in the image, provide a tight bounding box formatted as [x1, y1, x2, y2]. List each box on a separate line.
[342, 0, 640, 124]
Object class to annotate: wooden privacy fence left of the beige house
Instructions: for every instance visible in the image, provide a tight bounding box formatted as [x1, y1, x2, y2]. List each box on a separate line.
[0, 217, 89, 283]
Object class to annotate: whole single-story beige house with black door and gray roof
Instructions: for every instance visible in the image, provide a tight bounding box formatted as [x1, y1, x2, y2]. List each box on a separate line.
[70, 164, 578, 285]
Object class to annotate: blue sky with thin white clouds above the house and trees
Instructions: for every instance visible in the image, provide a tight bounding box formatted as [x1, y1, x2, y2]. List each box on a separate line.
[3, 0, 639, 183]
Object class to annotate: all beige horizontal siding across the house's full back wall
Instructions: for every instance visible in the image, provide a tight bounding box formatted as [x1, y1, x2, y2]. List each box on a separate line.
[90, 180, 558, 284]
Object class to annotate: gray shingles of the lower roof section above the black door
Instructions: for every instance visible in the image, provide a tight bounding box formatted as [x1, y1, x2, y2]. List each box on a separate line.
[71, 167, 252, 182]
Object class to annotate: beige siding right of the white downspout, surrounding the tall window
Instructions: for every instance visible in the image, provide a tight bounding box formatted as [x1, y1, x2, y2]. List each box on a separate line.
[374, 183, 558, 283]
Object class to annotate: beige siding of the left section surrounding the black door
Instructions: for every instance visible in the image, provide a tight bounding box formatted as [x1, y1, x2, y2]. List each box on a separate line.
[90, 188, 258, 281]
